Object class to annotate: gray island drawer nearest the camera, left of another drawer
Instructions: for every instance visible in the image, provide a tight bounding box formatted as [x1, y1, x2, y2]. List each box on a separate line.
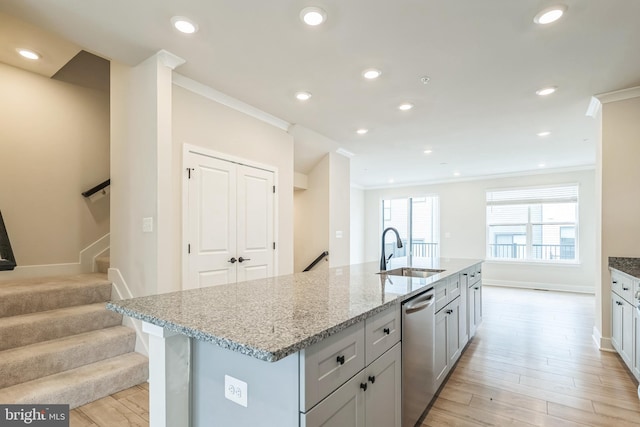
[300, 322, 365, 412]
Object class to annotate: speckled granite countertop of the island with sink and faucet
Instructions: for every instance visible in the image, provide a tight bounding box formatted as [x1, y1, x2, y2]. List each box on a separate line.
[107, 258, 482, 362]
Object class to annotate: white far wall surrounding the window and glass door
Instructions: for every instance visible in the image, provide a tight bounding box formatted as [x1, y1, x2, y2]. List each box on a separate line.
[365, 170, 595, 292]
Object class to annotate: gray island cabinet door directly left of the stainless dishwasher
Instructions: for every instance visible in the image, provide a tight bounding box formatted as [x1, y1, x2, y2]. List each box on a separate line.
[365, 343, 402, 427]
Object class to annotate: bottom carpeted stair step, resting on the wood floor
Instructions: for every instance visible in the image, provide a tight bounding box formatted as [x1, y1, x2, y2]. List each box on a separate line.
[0, 353, 149, 408]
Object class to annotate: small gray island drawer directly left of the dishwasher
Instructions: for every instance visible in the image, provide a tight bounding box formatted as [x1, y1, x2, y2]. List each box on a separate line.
[364, 304, 400, 365]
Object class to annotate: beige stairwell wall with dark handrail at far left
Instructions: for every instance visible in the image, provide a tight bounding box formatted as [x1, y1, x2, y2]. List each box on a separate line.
[0, 64, 109, 268]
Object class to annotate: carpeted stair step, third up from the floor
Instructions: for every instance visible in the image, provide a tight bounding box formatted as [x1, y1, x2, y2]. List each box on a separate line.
[0, 303, 122, 352]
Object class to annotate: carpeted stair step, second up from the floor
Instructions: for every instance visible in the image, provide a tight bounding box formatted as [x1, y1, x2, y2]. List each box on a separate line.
[0, 326, 136, 389]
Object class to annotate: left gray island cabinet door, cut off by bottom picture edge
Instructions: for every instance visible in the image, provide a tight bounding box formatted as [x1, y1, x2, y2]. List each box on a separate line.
[300, 371, 368, 427]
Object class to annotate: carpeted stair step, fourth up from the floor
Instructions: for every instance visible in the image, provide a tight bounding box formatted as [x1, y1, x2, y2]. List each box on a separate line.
[0, 273, 111, 318]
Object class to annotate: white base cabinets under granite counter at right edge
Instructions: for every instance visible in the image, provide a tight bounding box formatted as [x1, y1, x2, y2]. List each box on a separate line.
[611, 269, 640, 379]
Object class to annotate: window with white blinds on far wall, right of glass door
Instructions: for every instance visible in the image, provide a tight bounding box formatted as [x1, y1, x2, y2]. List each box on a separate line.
[487, 185, 578, 262]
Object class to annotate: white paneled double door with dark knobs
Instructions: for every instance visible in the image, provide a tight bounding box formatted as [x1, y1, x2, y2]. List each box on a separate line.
[183, 151, 275, 289]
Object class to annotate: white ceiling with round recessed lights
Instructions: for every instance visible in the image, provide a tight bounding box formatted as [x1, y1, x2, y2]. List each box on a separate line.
[0, 0, 640, 188]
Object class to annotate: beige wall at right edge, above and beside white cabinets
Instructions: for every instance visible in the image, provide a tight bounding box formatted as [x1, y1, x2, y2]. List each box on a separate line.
[596, 97, 640, 346]
